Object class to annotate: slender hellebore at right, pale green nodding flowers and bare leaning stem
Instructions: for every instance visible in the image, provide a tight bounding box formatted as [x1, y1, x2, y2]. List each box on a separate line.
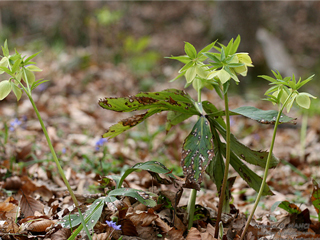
[241, 71, 316, 240]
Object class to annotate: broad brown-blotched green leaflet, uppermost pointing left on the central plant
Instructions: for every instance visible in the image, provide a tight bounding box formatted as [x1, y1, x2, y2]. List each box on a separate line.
[99, 89, 199, 115]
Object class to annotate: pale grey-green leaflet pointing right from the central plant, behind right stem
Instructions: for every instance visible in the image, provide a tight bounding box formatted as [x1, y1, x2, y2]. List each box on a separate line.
[230, 106, 295, 124]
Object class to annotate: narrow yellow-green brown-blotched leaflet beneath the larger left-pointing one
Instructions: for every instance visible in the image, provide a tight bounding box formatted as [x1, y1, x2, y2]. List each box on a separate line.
[102, 108, 164, 138]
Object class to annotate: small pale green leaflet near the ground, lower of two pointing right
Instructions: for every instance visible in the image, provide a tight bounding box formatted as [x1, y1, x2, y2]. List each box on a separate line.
[108, 188, 157, 207]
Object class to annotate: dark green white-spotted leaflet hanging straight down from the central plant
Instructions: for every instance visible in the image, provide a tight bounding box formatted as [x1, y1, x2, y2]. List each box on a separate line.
[181, 116, 214, 190]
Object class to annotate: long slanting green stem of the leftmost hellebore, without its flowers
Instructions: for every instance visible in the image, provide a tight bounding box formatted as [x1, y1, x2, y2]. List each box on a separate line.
[26, 92, 92, 240]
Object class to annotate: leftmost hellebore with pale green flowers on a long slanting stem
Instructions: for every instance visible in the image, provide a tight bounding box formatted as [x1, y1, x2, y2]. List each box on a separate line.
[0, 41, 91, 239]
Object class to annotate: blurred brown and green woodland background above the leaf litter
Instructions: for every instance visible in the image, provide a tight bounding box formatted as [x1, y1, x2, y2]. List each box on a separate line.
[0, 1, 320, 96]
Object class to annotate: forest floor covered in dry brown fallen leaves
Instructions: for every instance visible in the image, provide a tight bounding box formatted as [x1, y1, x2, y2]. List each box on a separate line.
[0, 45, 320, 240]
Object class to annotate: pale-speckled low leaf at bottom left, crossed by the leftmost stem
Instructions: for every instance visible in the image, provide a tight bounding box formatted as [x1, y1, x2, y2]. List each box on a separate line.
[61, 198, 105, 230]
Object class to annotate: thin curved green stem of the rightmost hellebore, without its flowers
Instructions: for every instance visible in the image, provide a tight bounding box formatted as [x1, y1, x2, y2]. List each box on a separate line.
[240, 93, 292, 240]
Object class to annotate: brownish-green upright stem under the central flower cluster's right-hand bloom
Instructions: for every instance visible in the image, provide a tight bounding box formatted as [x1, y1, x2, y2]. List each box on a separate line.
[214, 93, 230, 238]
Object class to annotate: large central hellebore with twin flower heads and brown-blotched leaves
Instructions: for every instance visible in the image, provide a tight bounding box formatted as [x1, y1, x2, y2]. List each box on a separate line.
[99, 36, 301, 238]
